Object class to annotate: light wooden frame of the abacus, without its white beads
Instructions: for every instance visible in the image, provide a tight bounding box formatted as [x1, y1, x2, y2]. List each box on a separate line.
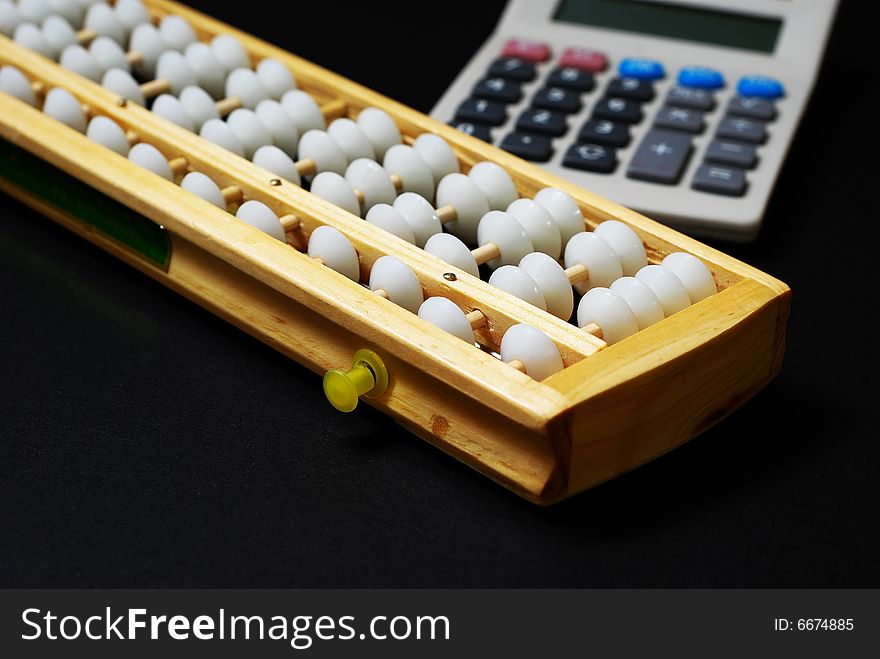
[0, 0, 790, 504]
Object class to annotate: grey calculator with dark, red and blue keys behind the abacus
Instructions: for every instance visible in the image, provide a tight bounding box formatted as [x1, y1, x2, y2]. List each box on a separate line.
[431, 0, 837, 241]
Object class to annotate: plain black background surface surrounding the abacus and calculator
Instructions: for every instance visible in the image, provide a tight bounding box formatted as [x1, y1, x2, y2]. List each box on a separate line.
[0, 0, 880, 587]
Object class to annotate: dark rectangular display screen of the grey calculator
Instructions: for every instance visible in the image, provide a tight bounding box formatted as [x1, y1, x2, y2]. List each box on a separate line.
[554, 0, 782, 53]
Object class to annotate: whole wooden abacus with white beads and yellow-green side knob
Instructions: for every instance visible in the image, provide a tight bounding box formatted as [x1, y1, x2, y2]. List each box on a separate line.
[0, 0, 790, 504]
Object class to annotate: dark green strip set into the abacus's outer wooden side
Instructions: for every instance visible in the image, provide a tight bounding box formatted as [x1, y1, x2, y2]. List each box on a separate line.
[0, 138, 171, 271]
